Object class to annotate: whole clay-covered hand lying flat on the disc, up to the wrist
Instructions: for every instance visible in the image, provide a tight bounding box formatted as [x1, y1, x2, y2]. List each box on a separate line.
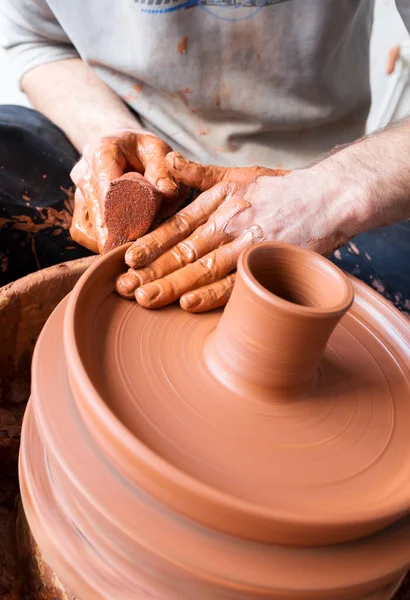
[117, 153, 352, 312]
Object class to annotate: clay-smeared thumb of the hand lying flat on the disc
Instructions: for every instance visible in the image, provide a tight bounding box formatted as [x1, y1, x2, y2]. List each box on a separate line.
[166, 152, 289, 191]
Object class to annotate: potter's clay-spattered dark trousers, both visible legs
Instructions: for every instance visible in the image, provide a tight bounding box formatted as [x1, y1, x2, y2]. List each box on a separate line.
[0, 106, 410, 316]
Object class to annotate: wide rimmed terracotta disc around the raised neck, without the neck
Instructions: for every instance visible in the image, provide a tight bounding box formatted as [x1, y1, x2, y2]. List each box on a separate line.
[65, 249, 410, 544]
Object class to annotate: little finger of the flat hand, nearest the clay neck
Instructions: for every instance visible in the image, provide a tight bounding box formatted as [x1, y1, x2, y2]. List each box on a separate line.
[179, 273, 236, 313]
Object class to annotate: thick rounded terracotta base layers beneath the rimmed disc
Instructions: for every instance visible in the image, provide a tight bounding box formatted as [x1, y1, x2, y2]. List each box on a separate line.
[20, 300, 410, 600]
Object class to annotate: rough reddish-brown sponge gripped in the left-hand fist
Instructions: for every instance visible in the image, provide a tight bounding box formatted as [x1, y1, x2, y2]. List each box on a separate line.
[103, 172, 162, 253]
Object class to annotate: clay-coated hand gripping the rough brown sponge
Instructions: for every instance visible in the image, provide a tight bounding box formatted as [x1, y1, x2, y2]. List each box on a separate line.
[71, 129, 186, 252]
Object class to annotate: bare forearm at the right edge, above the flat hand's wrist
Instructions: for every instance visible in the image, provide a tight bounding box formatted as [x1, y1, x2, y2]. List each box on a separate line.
[313, 118, 410, 237]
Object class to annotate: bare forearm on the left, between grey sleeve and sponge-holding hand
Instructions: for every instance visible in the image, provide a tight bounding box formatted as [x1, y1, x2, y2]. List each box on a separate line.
[22, 58, 141, 152]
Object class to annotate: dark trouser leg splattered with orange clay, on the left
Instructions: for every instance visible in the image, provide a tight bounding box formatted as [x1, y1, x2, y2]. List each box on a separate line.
[0, 106, 90, 286]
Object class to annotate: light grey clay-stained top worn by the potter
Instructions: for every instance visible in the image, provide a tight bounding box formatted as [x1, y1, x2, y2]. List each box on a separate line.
[0, 0, 410, 168]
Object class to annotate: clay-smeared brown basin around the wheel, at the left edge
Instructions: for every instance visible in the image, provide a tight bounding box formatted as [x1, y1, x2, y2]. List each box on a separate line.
[0, 258, 94, 600]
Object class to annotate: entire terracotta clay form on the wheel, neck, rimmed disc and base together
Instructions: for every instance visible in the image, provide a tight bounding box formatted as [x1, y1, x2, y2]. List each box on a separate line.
[20, 244, 410, 600]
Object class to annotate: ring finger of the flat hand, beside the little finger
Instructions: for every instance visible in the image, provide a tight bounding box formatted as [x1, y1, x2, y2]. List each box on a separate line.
[135, 225, 263, 308]
